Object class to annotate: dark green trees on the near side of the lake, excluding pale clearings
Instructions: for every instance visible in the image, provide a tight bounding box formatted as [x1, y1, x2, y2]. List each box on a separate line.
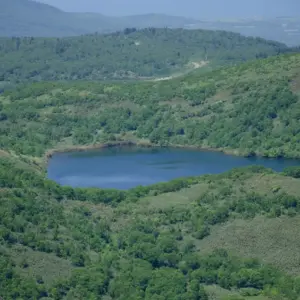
[0, 156, 300, 300]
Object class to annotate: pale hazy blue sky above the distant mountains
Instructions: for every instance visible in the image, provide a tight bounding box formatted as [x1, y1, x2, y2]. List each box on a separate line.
[40, 0, 300, 19]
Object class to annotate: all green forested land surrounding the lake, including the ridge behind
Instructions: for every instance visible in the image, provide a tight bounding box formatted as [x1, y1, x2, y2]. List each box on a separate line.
[0, 29, 300, 300]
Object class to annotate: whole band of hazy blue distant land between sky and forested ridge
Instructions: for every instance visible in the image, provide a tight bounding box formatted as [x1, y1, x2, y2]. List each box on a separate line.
[0, 0, 300, 46]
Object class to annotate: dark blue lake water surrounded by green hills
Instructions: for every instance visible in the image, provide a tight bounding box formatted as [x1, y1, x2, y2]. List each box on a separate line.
[48, 148, 300, 189]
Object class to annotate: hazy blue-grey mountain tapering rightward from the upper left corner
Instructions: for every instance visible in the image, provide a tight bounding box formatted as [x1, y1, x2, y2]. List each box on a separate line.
[0, 0, 195, 37]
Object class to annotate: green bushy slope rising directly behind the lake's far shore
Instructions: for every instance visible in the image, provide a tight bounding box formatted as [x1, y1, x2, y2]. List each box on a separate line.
[0, 54, 300, 157]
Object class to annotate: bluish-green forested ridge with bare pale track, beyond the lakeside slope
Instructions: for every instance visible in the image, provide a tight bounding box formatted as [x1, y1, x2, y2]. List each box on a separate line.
[0, 28, 292, 83]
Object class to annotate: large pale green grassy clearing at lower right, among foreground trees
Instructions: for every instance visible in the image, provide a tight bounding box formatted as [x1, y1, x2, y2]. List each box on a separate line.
[197, 216, 300, 275]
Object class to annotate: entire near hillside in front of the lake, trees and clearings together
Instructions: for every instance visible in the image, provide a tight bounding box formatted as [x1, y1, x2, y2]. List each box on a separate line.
[0, 152, 300, 300]
